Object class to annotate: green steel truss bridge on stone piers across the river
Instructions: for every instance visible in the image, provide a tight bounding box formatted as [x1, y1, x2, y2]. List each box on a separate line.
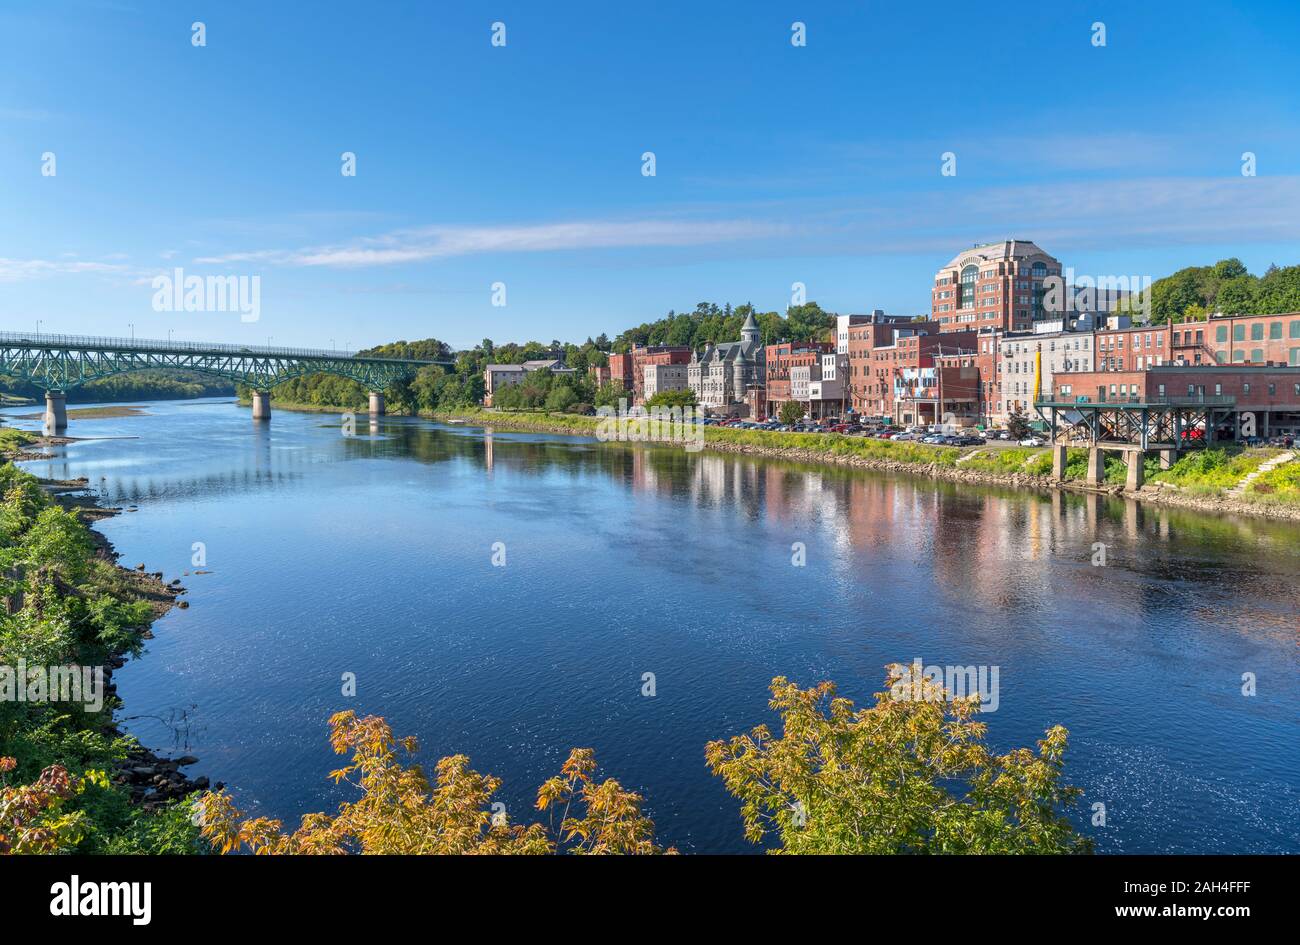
[0, 331, 451, 430]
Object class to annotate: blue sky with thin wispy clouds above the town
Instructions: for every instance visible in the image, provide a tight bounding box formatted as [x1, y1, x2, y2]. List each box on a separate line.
[0, 0, 1300, 348]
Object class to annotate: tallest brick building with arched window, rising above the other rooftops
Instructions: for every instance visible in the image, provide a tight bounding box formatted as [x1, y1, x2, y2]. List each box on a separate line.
[931, 239, 1061, 331]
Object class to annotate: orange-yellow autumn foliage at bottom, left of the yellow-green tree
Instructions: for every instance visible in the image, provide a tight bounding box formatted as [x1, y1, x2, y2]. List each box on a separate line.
[198, 711, 672, 854]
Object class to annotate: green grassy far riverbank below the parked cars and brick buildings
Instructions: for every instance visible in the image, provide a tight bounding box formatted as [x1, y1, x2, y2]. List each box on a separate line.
[421, 407, 1300, 521]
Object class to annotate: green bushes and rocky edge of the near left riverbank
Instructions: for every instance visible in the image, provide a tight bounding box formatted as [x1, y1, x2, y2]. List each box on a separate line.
[0, 429, 208, 854]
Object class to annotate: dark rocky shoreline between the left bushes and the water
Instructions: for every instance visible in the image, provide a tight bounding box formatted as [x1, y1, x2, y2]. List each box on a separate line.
[5, 437, 225, 811]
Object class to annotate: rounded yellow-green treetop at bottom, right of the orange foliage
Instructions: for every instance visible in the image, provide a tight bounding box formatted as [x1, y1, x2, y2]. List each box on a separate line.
[705, 666, 1092, 854]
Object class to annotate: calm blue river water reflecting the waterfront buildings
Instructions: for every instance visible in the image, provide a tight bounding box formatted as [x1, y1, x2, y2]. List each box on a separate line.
[10, 400, 1300, 853]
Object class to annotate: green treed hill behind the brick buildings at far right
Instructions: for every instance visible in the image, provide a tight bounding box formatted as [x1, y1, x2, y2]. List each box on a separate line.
[1151, 259, 1300, 322]
